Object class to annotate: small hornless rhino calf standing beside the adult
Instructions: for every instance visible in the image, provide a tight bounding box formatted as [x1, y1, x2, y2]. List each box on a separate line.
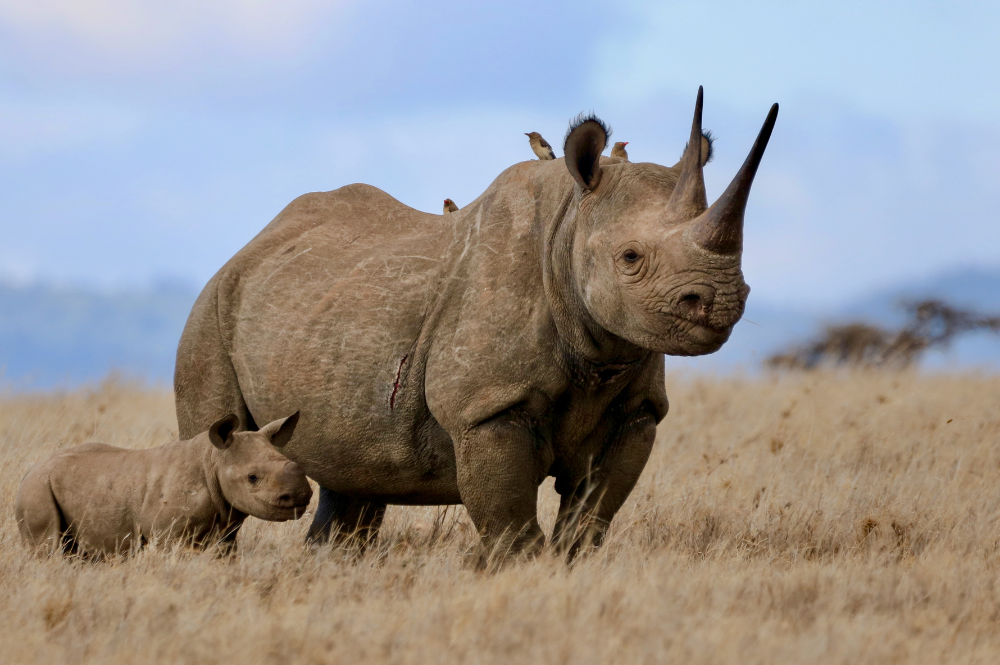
[14, 412, 312, 556]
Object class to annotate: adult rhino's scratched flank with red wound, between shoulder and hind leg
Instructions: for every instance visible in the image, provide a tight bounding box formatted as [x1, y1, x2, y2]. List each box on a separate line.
[210, 185, 464, 501]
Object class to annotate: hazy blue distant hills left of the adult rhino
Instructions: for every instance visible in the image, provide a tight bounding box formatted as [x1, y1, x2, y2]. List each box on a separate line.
[0, 282, 198, 388]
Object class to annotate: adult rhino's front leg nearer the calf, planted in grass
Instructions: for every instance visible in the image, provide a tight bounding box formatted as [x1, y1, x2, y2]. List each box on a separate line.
[455, 414, 552, 568]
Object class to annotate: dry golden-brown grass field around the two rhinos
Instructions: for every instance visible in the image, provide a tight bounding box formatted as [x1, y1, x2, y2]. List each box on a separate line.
[0, 372, 1000, 665]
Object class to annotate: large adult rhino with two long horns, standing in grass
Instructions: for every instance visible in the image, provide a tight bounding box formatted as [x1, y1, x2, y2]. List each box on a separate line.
[174, 90, 777, 563]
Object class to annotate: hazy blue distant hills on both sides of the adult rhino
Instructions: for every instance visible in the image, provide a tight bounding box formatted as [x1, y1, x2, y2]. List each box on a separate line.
[0, 269, 1000, 389]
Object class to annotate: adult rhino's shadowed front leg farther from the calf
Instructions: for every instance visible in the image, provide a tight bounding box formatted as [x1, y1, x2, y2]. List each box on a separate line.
[552, 408, 656, 560]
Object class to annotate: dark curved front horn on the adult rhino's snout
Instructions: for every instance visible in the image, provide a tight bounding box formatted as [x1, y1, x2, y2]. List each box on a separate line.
[685, 104, 778, 254]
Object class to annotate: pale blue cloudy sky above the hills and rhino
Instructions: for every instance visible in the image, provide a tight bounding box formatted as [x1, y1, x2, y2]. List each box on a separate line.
[0, 0, 1000, 307]
